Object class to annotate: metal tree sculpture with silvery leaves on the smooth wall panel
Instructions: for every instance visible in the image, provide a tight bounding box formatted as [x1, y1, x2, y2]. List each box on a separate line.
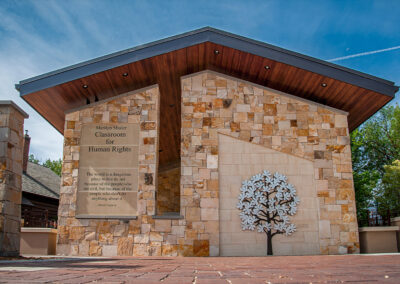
[237, 171, 300, 255]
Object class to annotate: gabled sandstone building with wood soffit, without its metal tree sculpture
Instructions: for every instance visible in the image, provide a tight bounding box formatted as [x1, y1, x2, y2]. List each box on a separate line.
[17, 28, 398, 256]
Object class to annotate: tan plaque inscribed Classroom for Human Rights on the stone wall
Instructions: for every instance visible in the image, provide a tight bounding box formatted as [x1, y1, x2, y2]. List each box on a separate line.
[76, 123, 140, 218]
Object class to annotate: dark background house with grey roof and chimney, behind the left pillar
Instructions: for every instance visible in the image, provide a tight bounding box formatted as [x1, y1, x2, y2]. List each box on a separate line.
[21, 134, 60, 228]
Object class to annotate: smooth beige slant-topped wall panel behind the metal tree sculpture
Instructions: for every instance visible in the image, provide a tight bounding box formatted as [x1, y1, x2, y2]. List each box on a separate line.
[218, 134, 320, 256]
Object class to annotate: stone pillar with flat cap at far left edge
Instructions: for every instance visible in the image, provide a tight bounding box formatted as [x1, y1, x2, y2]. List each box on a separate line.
[0, 101, 28, 256]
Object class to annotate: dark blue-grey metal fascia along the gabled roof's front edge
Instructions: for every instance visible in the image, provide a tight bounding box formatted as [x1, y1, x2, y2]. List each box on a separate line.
[16, 27, 399, 97]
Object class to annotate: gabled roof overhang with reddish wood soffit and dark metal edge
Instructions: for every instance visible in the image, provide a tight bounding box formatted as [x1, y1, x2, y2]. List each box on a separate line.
[16, 27, 398, 163]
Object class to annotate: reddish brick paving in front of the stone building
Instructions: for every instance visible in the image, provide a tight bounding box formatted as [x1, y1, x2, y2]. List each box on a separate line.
[0, 254, 400, 284]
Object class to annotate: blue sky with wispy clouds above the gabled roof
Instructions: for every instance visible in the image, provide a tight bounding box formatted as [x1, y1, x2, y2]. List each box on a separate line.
[0, 0, 400, 160]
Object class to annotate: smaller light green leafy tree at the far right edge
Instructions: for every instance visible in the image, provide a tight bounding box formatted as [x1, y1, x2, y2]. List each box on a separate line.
[376, 160, 400, 222]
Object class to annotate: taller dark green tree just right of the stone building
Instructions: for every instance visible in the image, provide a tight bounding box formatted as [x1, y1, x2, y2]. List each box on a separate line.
[350, 105, 400, 225]
